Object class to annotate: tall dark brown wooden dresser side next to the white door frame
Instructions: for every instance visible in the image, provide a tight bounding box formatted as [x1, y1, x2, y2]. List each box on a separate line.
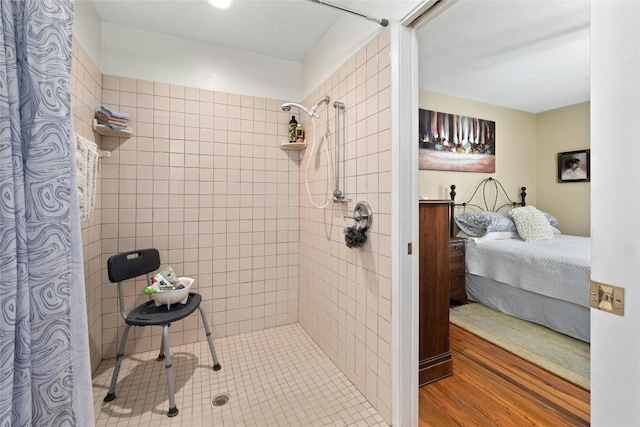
[418, 200, 453, 386]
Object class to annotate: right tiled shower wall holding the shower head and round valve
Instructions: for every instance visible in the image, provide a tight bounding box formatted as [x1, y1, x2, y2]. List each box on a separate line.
[300, 30, 391, 422]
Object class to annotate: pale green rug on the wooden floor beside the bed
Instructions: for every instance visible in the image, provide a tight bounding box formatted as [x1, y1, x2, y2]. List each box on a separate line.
[449, 303, 591, 390]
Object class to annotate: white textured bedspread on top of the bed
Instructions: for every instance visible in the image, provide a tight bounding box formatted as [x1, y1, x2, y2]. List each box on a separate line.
[465, 234, 591, 307]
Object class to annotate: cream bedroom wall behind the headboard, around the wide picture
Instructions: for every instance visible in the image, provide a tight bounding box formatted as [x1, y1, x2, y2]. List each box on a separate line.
[416, 90, 537, 208]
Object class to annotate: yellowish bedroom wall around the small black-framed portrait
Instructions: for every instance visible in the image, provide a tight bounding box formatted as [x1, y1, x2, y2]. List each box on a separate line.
[536, 102, 591, 236]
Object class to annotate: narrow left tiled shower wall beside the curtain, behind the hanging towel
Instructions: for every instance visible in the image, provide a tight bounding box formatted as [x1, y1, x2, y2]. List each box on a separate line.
[71, 41, 102, 371]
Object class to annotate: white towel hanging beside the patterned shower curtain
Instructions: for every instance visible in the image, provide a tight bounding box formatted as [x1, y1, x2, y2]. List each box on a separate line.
[75, 133, 99, 221]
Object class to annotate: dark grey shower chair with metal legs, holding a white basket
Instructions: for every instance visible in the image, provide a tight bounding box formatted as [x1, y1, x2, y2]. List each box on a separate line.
[104, 248, 222, 417]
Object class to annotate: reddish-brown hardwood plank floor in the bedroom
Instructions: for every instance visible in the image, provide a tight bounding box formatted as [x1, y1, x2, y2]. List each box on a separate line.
[418, 324, 590, 427]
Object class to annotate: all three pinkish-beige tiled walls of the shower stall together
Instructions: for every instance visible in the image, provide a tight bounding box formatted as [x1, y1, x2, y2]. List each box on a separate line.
[71, 29, 391, 425]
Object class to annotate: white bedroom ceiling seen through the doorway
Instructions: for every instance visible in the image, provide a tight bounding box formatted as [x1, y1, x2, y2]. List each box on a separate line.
[418, 0, 590, 113]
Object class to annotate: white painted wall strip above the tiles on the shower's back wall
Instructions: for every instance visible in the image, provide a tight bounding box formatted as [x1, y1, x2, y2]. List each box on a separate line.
[102, 22, 301, 101]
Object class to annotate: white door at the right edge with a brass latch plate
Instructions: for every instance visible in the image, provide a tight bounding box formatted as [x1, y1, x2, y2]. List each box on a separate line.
[591, 1, 640, 426]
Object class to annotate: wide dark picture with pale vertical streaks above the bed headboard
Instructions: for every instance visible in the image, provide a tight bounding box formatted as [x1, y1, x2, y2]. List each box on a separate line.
[418, 109, 496, 173]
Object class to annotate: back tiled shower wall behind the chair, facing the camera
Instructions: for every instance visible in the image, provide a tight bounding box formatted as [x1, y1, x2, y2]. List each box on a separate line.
[101, 75, 300, 358]
